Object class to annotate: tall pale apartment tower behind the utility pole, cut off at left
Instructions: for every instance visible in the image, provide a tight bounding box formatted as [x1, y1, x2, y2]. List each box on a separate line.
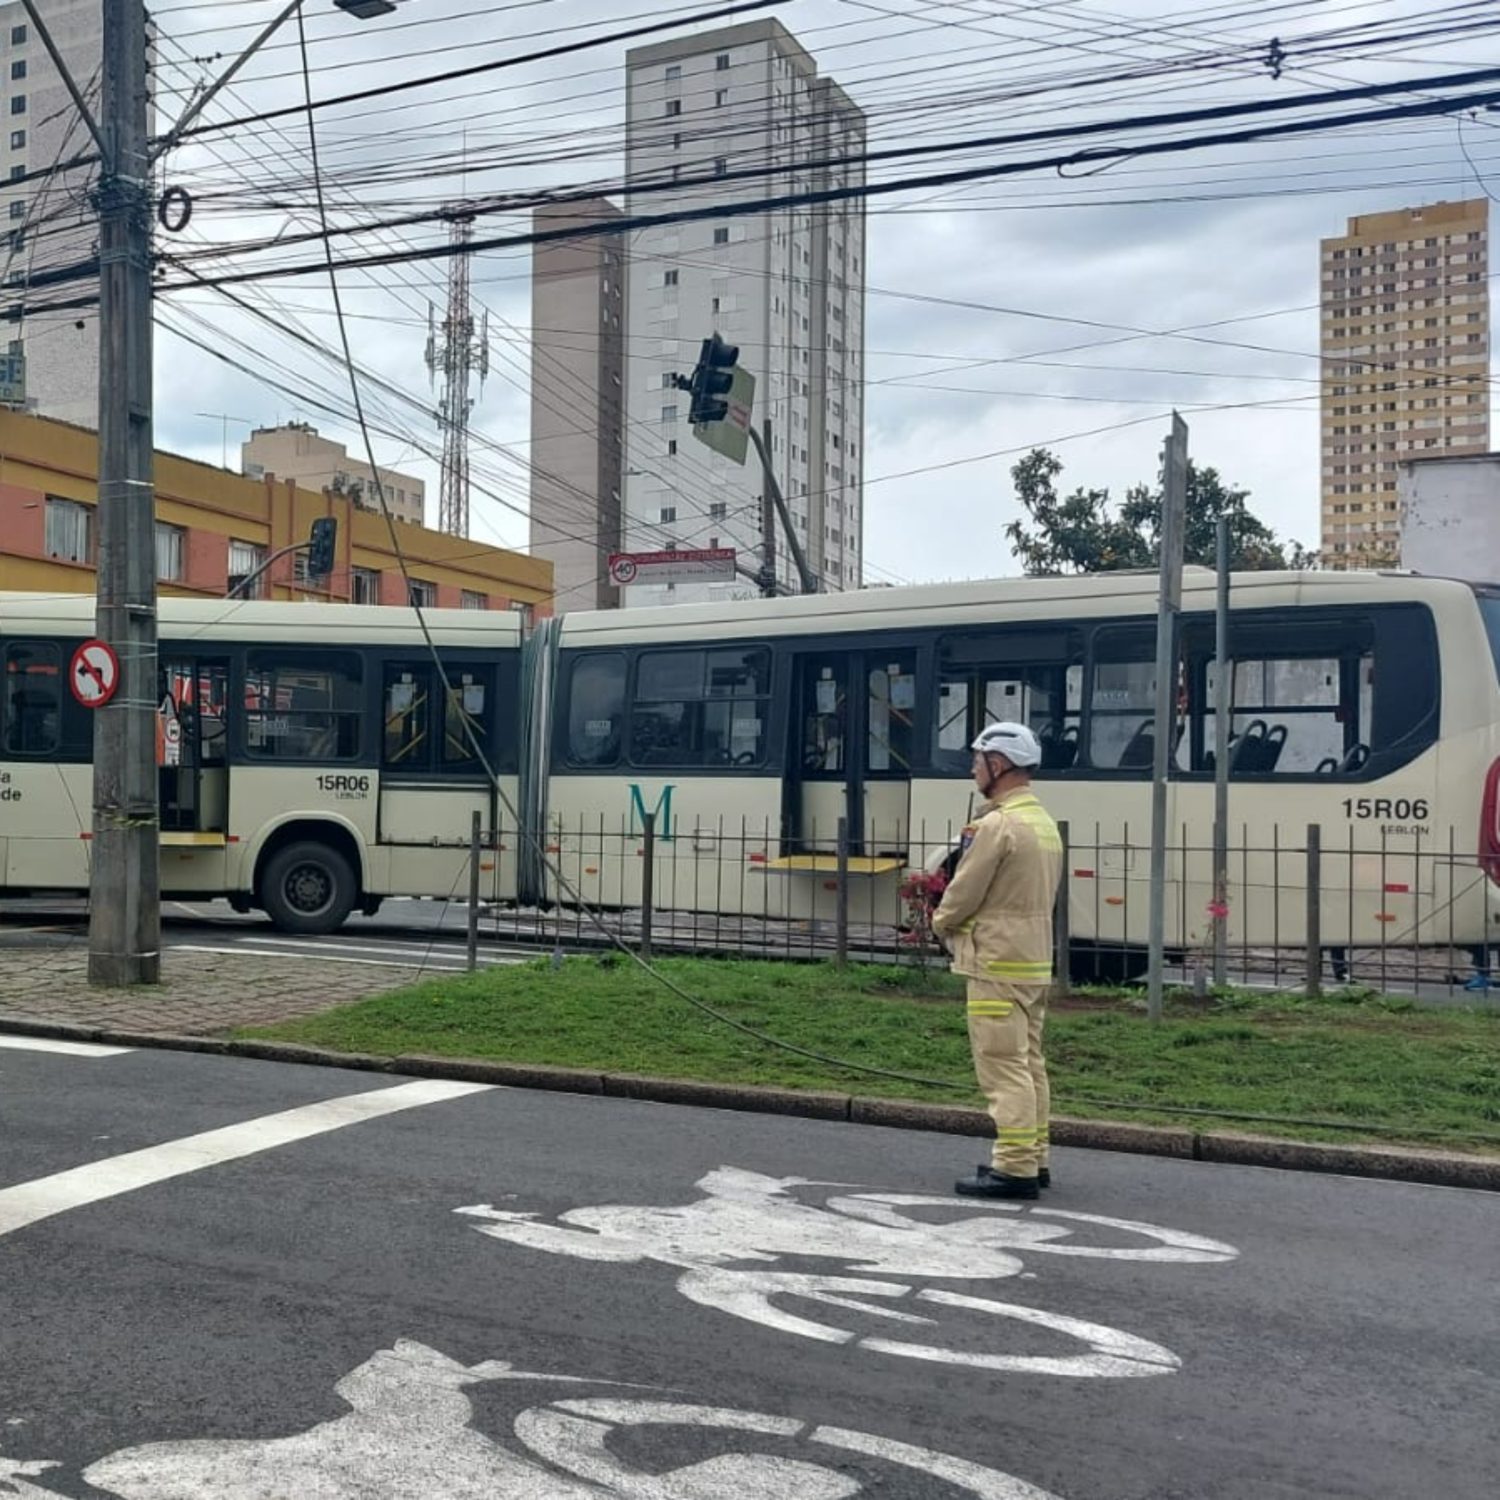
[0, 0, 104, 428]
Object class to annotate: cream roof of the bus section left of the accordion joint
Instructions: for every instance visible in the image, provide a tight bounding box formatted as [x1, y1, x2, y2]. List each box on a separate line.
[0, 593, 521, 650]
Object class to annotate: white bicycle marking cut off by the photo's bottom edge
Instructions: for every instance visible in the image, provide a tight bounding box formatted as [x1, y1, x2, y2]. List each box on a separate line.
[0, 1340, 1080, 1500]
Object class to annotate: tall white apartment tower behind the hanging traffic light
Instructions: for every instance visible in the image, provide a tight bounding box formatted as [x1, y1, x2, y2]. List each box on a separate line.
[624, 21, 866, 605]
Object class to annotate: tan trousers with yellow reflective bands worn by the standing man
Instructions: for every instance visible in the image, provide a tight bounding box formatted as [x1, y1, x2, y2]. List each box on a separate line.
[969, 980, 1052, 1178]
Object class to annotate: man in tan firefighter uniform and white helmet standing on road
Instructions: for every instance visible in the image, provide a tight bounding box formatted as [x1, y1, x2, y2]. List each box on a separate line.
[933, 723, 1062, 1199]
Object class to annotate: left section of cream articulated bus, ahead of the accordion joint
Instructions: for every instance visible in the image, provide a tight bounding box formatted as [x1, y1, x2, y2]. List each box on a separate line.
[0, 594, 521, 933]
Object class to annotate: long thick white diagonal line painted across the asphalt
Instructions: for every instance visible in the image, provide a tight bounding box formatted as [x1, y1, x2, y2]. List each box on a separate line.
[0, 1079, 492, 1238]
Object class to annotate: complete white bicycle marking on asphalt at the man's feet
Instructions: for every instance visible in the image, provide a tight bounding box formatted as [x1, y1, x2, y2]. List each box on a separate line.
[456, 1167, 1239, 1379]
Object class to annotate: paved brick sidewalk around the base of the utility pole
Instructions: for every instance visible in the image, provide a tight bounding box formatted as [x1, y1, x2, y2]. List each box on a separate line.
[0, 938, 413, 1037]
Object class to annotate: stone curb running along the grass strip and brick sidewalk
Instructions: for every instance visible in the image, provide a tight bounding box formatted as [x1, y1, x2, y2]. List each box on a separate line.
[0, 1017, 1500, 1193]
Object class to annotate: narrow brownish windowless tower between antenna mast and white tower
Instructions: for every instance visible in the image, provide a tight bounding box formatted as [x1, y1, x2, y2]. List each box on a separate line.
[530, 198, 626, 615]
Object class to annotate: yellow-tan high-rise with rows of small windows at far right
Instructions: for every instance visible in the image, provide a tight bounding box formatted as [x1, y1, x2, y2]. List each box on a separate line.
[1320, 198, 1490, 567]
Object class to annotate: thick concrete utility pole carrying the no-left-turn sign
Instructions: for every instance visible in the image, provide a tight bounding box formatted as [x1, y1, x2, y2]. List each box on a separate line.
[89, 0, 161, 986]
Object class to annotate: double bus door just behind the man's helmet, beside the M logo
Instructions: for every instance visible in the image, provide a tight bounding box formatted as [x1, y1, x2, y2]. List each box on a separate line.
[788, 647, 917, 857]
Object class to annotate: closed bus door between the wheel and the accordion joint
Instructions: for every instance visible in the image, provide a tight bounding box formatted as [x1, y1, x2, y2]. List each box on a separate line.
[377, 659, 497, 900]
